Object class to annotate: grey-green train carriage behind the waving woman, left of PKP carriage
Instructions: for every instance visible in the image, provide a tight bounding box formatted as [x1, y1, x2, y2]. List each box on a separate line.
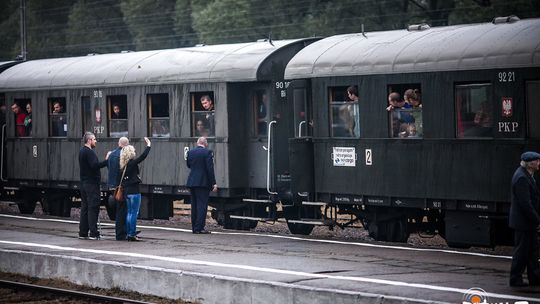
[0, 39, 314, 226]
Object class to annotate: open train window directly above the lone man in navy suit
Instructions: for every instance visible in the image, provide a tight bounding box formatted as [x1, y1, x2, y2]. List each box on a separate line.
[191, 92, 216, 137]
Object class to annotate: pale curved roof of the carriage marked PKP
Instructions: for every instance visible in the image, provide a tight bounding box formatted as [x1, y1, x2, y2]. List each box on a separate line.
[285, 19, 540, 79]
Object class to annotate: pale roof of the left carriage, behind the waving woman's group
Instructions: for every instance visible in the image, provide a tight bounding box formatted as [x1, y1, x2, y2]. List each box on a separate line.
[0, 39, 308, 91]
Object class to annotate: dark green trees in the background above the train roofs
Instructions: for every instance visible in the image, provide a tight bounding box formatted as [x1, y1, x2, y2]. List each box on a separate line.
[0, 0, 540, 61]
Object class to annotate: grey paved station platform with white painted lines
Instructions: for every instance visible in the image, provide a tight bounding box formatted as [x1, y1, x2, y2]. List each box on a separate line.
[0, 214, 540, 303]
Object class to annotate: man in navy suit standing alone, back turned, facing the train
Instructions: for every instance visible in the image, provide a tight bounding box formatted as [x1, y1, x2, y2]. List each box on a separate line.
[186, 137, 217, 234]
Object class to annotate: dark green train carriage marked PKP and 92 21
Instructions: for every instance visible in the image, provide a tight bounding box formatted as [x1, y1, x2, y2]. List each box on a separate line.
[285, 17, 540, 246]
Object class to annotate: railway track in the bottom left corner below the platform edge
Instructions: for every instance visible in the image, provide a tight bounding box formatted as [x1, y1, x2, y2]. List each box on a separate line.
[0, 280, 153, 304]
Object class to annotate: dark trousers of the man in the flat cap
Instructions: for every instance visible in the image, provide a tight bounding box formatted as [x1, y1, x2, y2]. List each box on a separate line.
[510, 230, 540, 285]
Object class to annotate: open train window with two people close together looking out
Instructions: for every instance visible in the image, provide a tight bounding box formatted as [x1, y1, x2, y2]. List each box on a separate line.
[386, 83, 424, 138]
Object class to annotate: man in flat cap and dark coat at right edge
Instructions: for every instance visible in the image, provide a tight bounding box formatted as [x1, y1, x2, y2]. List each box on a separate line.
[509, 152, 540, 287]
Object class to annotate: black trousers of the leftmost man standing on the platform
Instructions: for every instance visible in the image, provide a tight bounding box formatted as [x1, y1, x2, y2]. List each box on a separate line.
[79, 183, 101, 237]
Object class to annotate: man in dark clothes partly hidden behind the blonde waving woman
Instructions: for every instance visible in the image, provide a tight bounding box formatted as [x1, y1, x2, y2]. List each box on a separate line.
[105, 137, 129, 241]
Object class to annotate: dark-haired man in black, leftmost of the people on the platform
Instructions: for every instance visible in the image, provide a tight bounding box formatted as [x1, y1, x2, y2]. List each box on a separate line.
[79, 132, 107, 240]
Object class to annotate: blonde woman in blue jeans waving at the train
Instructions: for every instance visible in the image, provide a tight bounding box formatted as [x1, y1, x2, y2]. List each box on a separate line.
[120, 137, 150, 242]
